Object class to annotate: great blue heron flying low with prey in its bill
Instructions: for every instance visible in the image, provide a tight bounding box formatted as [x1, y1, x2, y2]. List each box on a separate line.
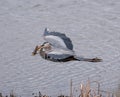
[32, 28, 101, 62]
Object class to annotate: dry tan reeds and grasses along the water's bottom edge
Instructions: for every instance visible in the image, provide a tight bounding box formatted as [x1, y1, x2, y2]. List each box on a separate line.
[0, 80, 120, 97]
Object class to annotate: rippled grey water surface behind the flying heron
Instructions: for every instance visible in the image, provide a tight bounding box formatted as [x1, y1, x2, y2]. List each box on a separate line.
[0, 0, 120, 97]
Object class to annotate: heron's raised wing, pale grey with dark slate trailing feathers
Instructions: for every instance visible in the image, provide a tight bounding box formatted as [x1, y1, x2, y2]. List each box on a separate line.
[44, 28, 73, 50]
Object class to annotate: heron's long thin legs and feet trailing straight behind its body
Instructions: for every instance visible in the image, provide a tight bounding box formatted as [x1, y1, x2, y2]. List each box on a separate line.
[74, 56, 102, 62]
